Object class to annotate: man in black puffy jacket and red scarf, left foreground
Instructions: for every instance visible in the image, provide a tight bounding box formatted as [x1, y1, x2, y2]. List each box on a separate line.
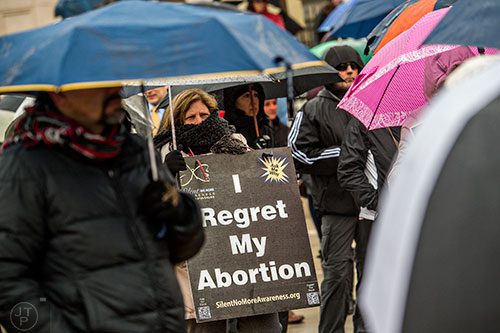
[0, 88, 204, 333]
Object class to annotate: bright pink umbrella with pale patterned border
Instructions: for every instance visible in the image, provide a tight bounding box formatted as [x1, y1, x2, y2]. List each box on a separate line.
[339, 8, 494, 129]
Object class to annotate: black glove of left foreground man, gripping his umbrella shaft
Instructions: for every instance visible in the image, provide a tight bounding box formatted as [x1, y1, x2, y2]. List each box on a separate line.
[139, 181, 184, 238]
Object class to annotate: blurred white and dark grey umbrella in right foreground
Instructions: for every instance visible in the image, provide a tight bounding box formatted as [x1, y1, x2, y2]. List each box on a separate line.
[360, 57, 500, 333]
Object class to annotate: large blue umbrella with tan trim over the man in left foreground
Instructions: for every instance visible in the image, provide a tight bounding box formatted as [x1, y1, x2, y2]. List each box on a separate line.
[0, 1, 327, 92]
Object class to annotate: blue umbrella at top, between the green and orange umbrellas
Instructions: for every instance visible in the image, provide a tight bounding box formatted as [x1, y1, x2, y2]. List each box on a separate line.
[323, 0, 405, 39]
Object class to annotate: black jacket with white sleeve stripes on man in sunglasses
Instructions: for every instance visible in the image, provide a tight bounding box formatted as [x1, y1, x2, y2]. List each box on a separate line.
[288, 88, 359, 216]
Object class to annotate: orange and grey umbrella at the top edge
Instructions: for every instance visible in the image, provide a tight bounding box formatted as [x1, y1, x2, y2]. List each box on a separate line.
[367, 0, 456, 53]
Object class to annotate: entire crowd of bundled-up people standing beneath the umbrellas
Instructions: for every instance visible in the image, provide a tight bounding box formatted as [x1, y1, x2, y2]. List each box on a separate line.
[0, 0, 494, 333]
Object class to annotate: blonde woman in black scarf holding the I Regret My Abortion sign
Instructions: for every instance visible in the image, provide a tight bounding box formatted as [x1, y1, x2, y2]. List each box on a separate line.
[154, 89, 281, 333]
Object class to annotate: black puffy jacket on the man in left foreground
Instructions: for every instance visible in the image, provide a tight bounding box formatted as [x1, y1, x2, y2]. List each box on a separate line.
[0, 135, 203, 333]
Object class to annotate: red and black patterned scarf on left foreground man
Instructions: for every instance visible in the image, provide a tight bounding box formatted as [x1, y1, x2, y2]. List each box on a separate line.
[0, 107, 125, 160]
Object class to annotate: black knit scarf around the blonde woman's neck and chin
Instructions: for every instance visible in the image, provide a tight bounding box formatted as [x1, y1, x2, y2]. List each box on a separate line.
[154, 111, 244, 155]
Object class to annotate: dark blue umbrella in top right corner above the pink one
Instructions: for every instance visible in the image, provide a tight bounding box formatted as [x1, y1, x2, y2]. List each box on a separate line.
[424, 0, 500, 49]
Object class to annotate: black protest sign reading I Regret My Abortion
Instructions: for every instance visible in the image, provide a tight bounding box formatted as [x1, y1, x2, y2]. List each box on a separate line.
[180, 148, 319, 321]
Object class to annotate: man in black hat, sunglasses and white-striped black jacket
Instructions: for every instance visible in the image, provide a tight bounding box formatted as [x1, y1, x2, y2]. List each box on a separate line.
[288, 46, 363, 333]
